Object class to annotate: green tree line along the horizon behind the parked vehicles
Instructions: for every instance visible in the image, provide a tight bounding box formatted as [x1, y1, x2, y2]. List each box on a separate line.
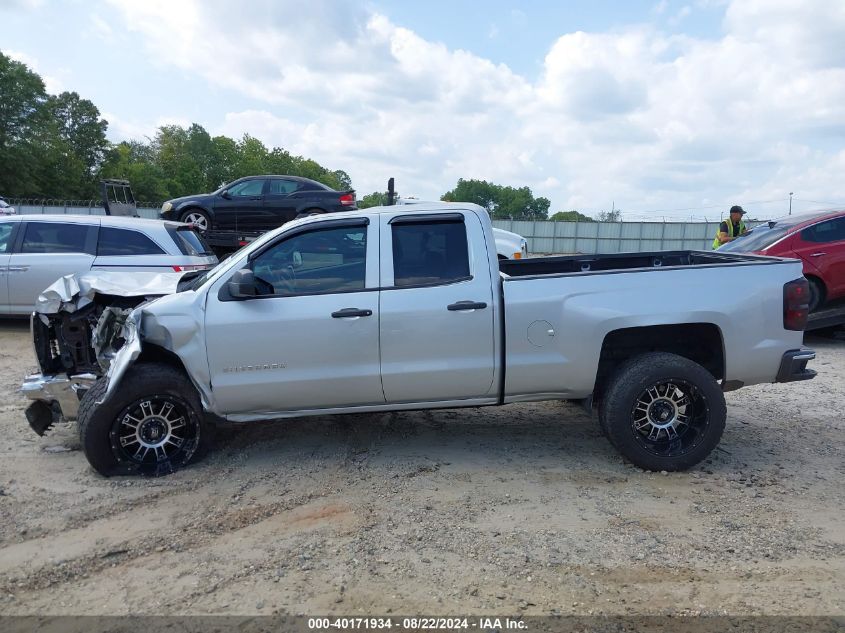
[0, 51, 618, 222]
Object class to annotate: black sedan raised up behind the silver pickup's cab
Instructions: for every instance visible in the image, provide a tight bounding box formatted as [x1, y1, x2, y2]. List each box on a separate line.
[159, 176, 358, 231]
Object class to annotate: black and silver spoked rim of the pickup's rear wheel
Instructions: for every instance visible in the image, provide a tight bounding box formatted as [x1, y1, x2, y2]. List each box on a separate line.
[631, 379, 710, 457]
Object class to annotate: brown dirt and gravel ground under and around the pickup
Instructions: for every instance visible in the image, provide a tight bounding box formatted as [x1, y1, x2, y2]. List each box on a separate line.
[0, 321, 845, 615]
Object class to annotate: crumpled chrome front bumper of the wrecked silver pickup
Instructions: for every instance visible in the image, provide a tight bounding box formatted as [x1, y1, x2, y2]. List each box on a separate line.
[21, 374, 97, 435]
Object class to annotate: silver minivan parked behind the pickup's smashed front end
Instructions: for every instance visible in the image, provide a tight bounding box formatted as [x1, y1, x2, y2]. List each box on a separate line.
[0, 214, 217, 316]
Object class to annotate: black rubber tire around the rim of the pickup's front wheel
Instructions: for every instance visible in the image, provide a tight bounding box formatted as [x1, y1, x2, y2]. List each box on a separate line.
[78, 363, 212, 477]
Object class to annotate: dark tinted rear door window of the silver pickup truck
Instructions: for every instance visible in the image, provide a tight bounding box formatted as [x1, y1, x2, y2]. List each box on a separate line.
[390, 214, 471, 288]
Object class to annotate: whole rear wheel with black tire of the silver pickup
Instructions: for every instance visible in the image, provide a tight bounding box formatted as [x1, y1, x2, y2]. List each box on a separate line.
[599, 352, 727, 471]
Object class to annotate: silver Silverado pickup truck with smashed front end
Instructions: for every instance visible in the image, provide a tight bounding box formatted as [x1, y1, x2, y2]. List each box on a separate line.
[22, 203, 815, 476]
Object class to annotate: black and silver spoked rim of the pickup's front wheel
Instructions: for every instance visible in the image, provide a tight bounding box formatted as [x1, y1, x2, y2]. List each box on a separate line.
[110, 395, 200, 474]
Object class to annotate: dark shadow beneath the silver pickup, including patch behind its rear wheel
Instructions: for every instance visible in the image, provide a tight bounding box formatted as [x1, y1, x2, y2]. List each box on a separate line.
[196, 402, 782, 474]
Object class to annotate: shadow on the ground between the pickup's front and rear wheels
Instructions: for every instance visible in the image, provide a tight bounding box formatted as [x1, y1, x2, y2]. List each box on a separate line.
[211, 402, 618, 472]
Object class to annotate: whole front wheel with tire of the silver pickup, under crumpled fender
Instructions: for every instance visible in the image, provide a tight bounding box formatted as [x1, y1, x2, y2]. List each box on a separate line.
[79, 363, 210, 477]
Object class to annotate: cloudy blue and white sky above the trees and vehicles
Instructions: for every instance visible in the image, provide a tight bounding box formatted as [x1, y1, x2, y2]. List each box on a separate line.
[0, 0, 845, 220]
